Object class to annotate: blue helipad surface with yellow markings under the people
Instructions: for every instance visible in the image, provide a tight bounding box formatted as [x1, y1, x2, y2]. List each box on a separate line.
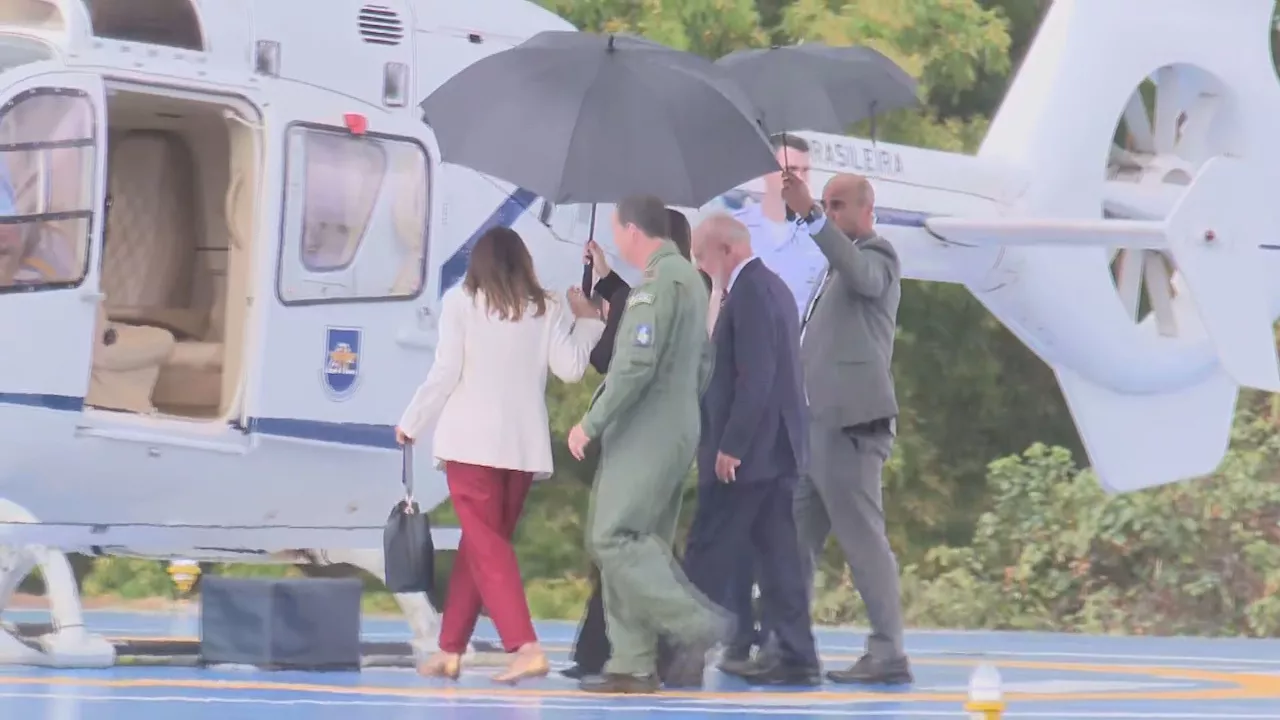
[0, 602, 1280, 720]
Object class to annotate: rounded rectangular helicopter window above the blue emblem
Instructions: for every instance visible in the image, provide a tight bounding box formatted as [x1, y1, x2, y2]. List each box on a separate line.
[279, 126, 430, 302]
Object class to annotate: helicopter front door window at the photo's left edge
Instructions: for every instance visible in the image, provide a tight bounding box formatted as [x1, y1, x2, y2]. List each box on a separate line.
[0, 88, 96, 292]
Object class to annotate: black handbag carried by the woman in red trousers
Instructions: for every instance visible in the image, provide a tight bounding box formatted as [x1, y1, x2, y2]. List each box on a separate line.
[383, 443, 435, 593]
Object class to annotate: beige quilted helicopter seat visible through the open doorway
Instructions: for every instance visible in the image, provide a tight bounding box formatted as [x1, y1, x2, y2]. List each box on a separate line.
[91, 131, 221, 411]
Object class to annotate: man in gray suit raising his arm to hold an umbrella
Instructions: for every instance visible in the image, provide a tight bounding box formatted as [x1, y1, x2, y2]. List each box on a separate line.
[782, 173, 913, 684]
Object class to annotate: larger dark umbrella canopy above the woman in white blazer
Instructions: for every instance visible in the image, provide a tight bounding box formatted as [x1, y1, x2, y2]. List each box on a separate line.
[421, 31, 778, 208]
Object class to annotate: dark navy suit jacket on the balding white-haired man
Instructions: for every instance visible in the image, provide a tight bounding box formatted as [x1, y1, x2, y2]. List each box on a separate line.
[698, 258, 809, 483]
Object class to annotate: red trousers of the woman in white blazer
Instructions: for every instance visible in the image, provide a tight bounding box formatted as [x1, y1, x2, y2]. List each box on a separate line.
[440, 462, 538, 655]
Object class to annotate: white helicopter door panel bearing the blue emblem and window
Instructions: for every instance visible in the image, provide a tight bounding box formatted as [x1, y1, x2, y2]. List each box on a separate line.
[244, 98, 435, 448]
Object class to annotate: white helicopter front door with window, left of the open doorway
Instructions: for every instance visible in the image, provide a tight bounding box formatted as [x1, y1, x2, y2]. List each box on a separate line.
[0, 63, 106, 422]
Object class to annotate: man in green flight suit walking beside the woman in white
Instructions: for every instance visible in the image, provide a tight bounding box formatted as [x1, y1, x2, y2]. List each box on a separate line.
[568, 196, 728, 693]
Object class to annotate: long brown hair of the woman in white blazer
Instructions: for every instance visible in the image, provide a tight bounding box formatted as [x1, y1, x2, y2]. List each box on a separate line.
[462, 227, 548, 322]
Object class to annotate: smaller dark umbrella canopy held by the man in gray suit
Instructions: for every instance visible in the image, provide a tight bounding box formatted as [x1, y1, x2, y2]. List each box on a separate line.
[716, 44, 919, 135]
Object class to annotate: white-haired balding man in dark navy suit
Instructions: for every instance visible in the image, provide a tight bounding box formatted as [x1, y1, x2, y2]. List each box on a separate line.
[685, 215, 822, 685]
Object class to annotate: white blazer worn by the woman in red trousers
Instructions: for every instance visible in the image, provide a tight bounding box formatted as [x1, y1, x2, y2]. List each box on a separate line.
[399, 286, 604, 479]
